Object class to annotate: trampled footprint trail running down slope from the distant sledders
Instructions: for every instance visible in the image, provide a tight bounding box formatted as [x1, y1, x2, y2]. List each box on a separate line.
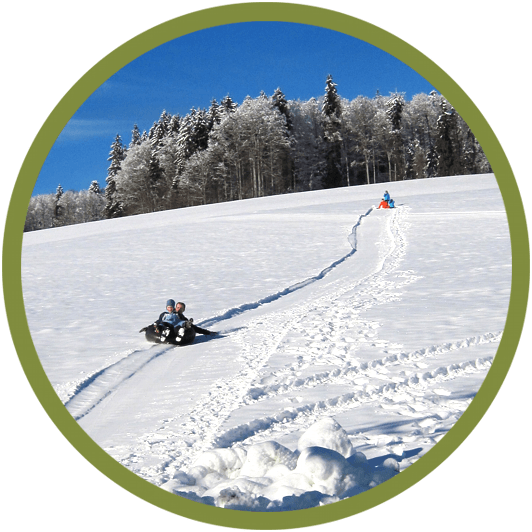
[149, 208, 418, 468]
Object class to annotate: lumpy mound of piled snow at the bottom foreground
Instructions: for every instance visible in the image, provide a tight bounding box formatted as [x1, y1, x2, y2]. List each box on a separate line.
[162, 418, 399, 511]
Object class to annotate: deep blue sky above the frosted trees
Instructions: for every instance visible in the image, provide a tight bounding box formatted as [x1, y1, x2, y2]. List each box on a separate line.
[33, 22, 434, 195]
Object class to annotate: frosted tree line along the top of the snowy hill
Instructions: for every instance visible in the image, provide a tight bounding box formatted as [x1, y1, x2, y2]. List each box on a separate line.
[23, 76, 491, 230]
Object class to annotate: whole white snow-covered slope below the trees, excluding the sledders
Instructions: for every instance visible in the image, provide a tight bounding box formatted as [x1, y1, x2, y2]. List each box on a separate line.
[22, 175, 511, 510]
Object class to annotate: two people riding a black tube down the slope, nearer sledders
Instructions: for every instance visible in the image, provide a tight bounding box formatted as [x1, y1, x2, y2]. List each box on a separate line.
[139, 299, 218, 345]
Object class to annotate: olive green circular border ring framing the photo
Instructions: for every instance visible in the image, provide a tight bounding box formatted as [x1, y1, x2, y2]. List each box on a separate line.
[2, 2, 530, 530]
